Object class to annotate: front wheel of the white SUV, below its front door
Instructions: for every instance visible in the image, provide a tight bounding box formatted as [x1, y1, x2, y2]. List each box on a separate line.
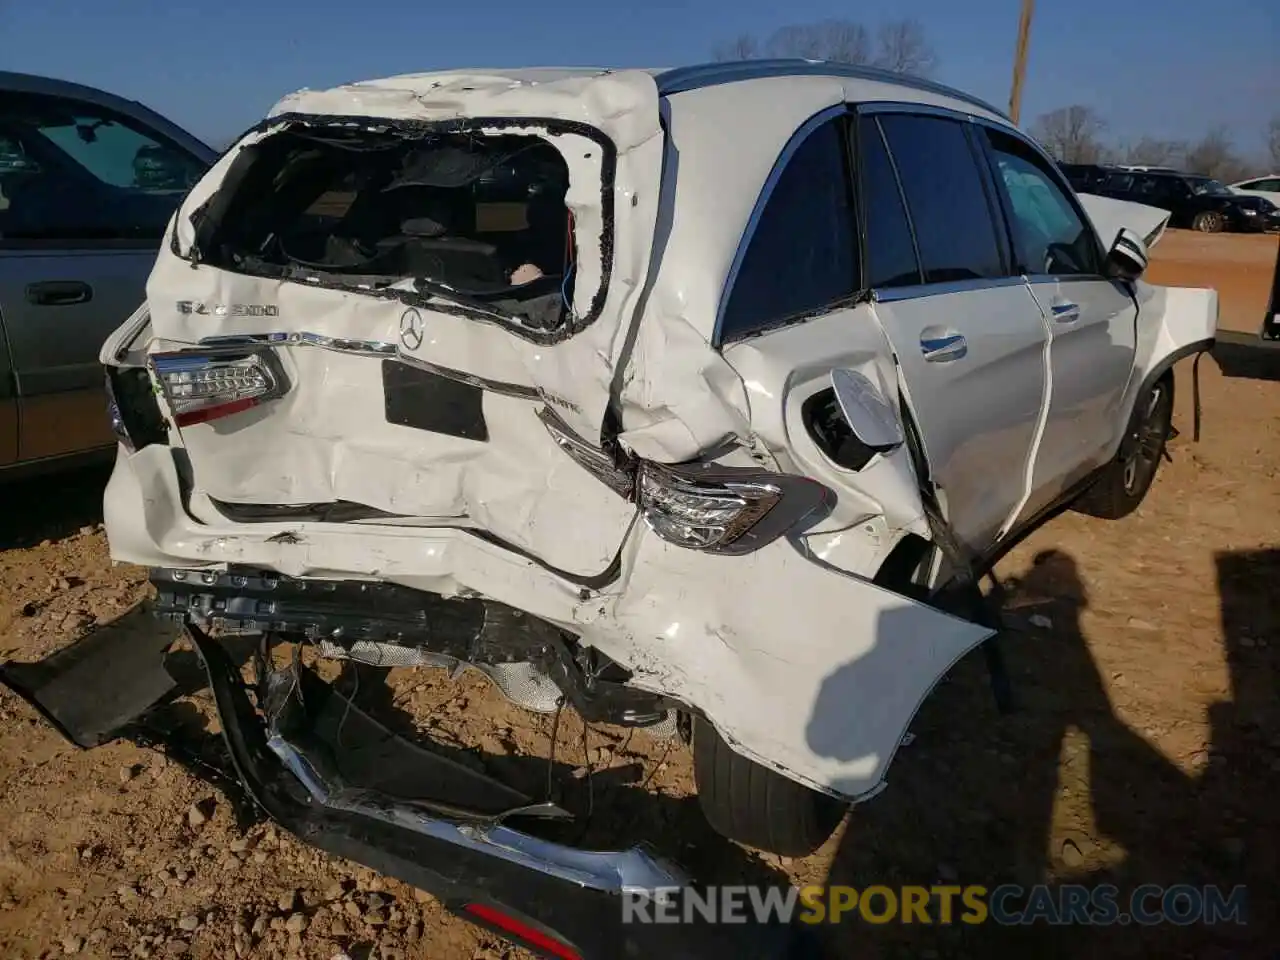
[1073, 374, 1174, 520]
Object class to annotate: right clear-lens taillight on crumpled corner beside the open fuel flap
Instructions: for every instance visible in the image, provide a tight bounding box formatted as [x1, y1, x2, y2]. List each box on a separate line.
[637, 461, 828, 554]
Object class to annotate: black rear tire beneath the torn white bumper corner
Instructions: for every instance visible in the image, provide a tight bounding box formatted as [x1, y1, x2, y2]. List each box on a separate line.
[694, 717, 849, 856]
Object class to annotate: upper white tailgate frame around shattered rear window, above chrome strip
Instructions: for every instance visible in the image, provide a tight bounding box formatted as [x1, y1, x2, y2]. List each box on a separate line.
[147, 70, 663, 442]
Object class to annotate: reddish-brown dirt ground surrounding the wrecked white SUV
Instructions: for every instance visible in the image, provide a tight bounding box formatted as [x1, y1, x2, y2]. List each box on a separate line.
[0, 232, 1280, 960]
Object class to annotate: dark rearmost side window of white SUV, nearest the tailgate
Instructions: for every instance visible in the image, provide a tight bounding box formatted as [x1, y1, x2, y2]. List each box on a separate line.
[721, 116, 861, 340]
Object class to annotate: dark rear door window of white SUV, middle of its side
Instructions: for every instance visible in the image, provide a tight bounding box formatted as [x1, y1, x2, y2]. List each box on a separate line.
[878, 114, 1009, 283]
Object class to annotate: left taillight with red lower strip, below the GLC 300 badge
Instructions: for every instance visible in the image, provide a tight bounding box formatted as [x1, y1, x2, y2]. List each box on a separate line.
[151, 352, 288, 426]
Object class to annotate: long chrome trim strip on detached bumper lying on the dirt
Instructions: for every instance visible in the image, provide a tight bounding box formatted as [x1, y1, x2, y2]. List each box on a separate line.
[268, 733, 687, 896]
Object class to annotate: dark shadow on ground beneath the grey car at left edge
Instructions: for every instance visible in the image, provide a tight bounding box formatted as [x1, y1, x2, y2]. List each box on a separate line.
[0, 465, 111, 550]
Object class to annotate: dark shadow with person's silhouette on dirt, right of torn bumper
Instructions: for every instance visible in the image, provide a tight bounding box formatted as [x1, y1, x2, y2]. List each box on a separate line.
[820, 550, 1280, 960]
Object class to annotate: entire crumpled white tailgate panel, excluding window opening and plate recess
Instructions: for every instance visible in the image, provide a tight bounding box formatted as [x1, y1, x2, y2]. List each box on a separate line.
[138, 70, 675, 579]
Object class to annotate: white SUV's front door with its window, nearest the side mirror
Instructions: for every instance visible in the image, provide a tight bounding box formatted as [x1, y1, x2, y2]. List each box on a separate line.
[979, 127, 1136, 518]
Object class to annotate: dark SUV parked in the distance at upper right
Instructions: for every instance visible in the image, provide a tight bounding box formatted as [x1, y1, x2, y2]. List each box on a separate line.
[1061, 164, 1280, 233]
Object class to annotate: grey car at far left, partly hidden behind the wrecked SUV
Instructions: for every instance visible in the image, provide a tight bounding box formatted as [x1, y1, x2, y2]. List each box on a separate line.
[0, 72, 216, 479]
